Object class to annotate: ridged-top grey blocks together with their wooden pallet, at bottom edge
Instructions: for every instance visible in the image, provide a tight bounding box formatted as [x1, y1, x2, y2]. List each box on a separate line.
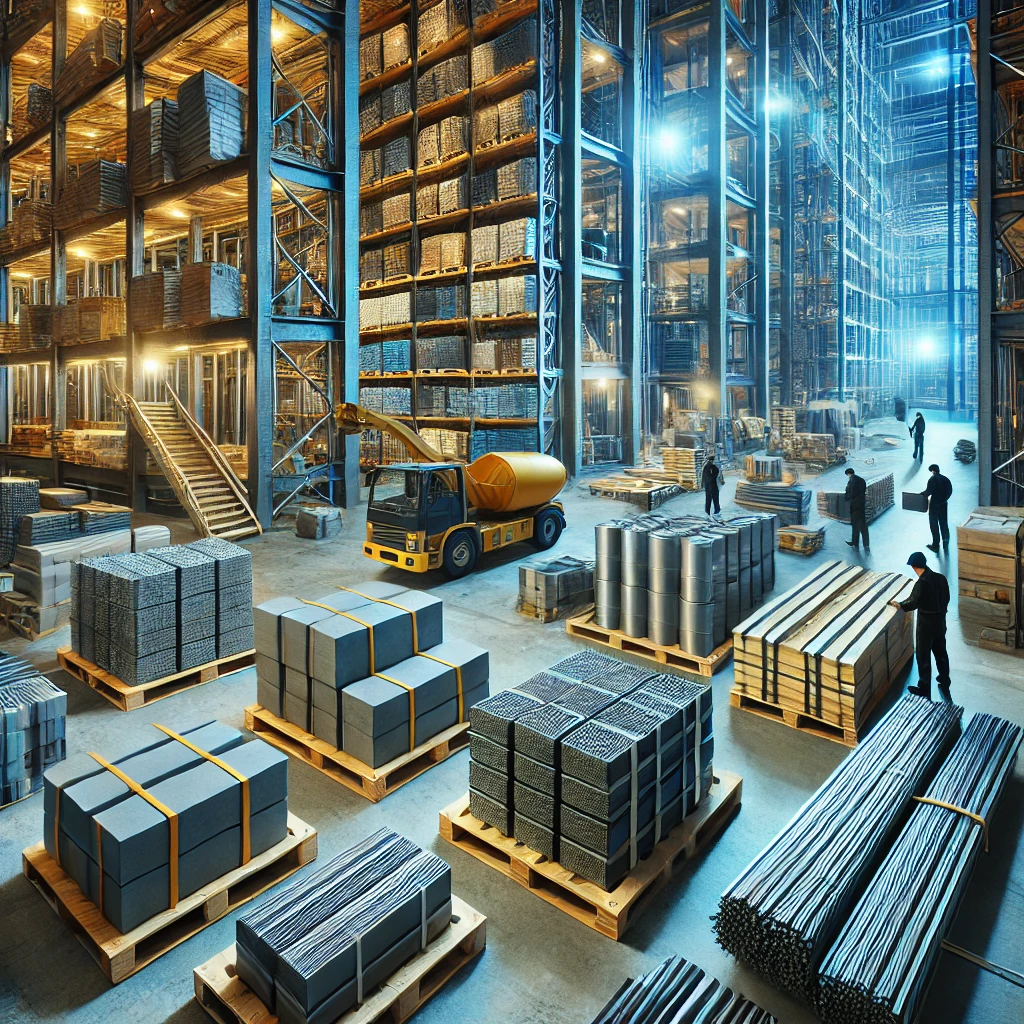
[194, 828, 486, 1024]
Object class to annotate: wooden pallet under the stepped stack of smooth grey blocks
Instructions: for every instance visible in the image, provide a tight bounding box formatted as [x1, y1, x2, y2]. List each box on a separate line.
[246, 705, 469, 804]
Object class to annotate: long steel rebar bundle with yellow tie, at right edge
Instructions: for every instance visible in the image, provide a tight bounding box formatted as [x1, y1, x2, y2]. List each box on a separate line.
[815, 715, 1024, 1024]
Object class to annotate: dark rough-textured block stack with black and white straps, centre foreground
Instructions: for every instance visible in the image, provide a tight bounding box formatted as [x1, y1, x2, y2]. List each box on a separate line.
[469, 651, 714, 890]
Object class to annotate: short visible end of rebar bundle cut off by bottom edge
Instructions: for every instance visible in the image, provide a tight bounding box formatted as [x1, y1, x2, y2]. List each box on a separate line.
[593, 956, 777, 1024]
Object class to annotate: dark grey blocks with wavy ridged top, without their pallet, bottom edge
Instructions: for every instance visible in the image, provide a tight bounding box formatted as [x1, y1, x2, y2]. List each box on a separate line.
[234, 828, 452, 1024]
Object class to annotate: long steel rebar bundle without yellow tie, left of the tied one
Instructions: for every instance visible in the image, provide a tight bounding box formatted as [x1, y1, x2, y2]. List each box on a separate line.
[713, 695, 963, 1001]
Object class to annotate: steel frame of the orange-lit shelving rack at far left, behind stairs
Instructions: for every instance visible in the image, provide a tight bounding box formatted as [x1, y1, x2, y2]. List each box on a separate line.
[0, 0, 359, 525]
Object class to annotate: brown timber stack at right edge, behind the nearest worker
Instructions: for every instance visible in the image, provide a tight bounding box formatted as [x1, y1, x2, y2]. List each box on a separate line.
[956, 507, 1024, 650]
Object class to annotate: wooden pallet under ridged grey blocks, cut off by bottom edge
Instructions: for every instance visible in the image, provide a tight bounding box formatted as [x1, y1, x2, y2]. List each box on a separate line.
[193, 896, 487, 1024]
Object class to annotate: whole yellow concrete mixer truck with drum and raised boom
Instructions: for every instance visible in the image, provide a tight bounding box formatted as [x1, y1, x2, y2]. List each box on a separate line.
[335, 402, 565, 580]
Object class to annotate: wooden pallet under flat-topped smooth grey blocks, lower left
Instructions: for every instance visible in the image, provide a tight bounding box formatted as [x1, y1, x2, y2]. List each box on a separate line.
[22, 813, 316, 985]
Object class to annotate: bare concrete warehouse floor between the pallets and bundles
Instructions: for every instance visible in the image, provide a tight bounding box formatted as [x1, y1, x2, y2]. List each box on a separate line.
[0, 420, 1024, 1024]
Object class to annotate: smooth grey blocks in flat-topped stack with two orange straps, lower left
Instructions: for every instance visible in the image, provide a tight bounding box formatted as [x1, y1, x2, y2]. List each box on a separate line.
[43, 721, 288, 932]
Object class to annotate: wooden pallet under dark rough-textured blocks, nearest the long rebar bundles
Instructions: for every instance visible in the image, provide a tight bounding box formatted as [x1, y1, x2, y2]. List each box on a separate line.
[440, 771, 743, 941]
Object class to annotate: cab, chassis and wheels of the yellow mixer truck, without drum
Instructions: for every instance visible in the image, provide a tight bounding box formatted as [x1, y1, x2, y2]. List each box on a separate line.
[362, 462, 565, 579]
